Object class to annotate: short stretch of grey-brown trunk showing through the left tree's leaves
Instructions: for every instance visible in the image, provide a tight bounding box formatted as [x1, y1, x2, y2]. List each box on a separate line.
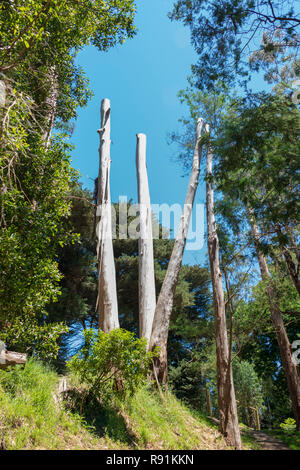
[42, 66, 59, 148]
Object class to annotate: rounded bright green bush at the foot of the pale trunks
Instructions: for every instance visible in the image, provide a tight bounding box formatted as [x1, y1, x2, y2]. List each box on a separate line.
[67, 328, 156, 400]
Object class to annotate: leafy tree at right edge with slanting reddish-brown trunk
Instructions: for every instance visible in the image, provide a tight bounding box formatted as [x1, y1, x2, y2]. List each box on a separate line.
[211, 95, 300, 428]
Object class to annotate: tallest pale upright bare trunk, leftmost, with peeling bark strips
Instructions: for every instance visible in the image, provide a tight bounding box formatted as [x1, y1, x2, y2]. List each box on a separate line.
[97, 99, 119, 333]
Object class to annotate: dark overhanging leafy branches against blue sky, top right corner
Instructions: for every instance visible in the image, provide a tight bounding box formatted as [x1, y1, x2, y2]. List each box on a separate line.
[169, 0, 299, 90]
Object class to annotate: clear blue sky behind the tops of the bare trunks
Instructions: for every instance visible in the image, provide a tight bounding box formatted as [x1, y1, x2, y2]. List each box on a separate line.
[72, 0, 264, 264]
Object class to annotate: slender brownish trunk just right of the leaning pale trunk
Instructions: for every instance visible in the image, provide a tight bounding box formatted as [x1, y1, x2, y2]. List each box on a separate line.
[205, 125, 241, 449]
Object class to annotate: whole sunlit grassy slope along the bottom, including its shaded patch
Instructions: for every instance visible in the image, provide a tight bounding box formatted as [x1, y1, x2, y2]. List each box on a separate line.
[0, 360, 253, 449]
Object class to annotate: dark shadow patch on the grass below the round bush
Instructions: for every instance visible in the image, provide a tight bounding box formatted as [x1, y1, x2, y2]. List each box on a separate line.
[64, 390, 137, 446]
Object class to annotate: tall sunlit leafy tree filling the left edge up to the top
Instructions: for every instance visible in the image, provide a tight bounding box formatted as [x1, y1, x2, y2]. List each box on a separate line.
[0, 0, 135, 356]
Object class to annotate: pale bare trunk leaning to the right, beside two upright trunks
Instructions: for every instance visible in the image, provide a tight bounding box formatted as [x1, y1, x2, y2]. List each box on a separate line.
[149, 119, 203, 383]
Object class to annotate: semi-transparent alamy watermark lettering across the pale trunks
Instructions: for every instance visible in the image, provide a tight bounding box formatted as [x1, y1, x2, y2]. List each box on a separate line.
[96, 196, 204, 251]
